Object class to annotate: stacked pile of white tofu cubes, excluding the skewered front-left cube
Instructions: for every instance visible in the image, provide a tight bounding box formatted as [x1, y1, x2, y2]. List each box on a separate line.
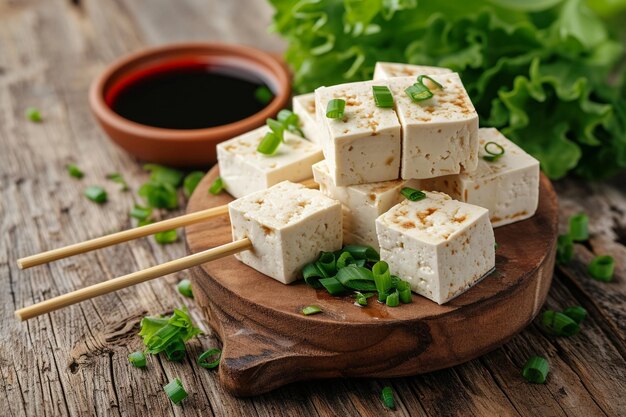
[218, 63, 539, 304]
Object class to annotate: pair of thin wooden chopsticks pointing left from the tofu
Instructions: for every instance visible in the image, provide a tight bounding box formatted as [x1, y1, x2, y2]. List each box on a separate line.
[15, 180, 317, 321]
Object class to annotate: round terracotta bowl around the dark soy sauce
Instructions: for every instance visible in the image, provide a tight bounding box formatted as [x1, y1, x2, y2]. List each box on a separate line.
[89, 43, 291, 167]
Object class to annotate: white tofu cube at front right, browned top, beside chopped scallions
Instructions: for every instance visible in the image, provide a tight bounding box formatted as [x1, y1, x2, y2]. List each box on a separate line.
[376, 192, 495, 304]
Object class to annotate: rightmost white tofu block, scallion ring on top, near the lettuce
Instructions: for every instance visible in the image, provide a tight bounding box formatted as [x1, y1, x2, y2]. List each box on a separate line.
[420, 128, 539, 227]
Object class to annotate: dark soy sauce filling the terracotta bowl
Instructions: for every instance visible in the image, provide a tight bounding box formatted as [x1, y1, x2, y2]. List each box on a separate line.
[106, 62, 271, 129]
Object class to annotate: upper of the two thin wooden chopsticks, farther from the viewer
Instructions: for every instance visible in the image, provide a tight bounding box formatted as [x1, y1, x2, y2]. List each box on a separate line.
[17, 178, 318, 269]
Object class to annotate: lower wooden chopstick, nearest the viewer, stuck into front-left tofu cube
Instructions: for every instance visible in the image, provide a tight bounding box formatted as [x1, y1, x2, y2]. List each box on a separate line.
[15, 238, 252, 321]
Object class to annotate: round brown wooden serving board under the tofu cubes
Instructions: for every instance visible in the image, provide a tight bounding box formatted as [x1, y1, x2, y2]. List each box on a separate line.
[186, 168, 558, 396]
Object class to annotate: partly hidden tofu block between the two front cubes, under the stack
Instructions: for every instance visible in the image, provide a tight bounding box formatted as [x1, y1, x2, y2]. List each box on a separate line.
[313, 161, 414, 250]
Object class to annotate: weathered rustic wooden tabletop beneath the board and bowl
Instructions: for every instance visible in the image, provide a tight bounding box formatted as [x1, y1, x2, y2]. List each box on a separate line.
[0, 0, 626, 417]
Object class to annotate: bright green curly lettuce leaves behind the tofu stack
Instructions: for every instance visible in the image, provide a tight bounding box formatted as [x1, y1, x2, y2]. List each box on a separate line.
[270, 0, 626, 179]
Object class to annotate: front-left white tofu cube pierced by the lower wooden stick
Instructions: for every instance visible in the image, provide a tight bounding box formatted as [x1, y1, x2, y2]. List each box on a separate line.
[228, 181, 342, 284]
